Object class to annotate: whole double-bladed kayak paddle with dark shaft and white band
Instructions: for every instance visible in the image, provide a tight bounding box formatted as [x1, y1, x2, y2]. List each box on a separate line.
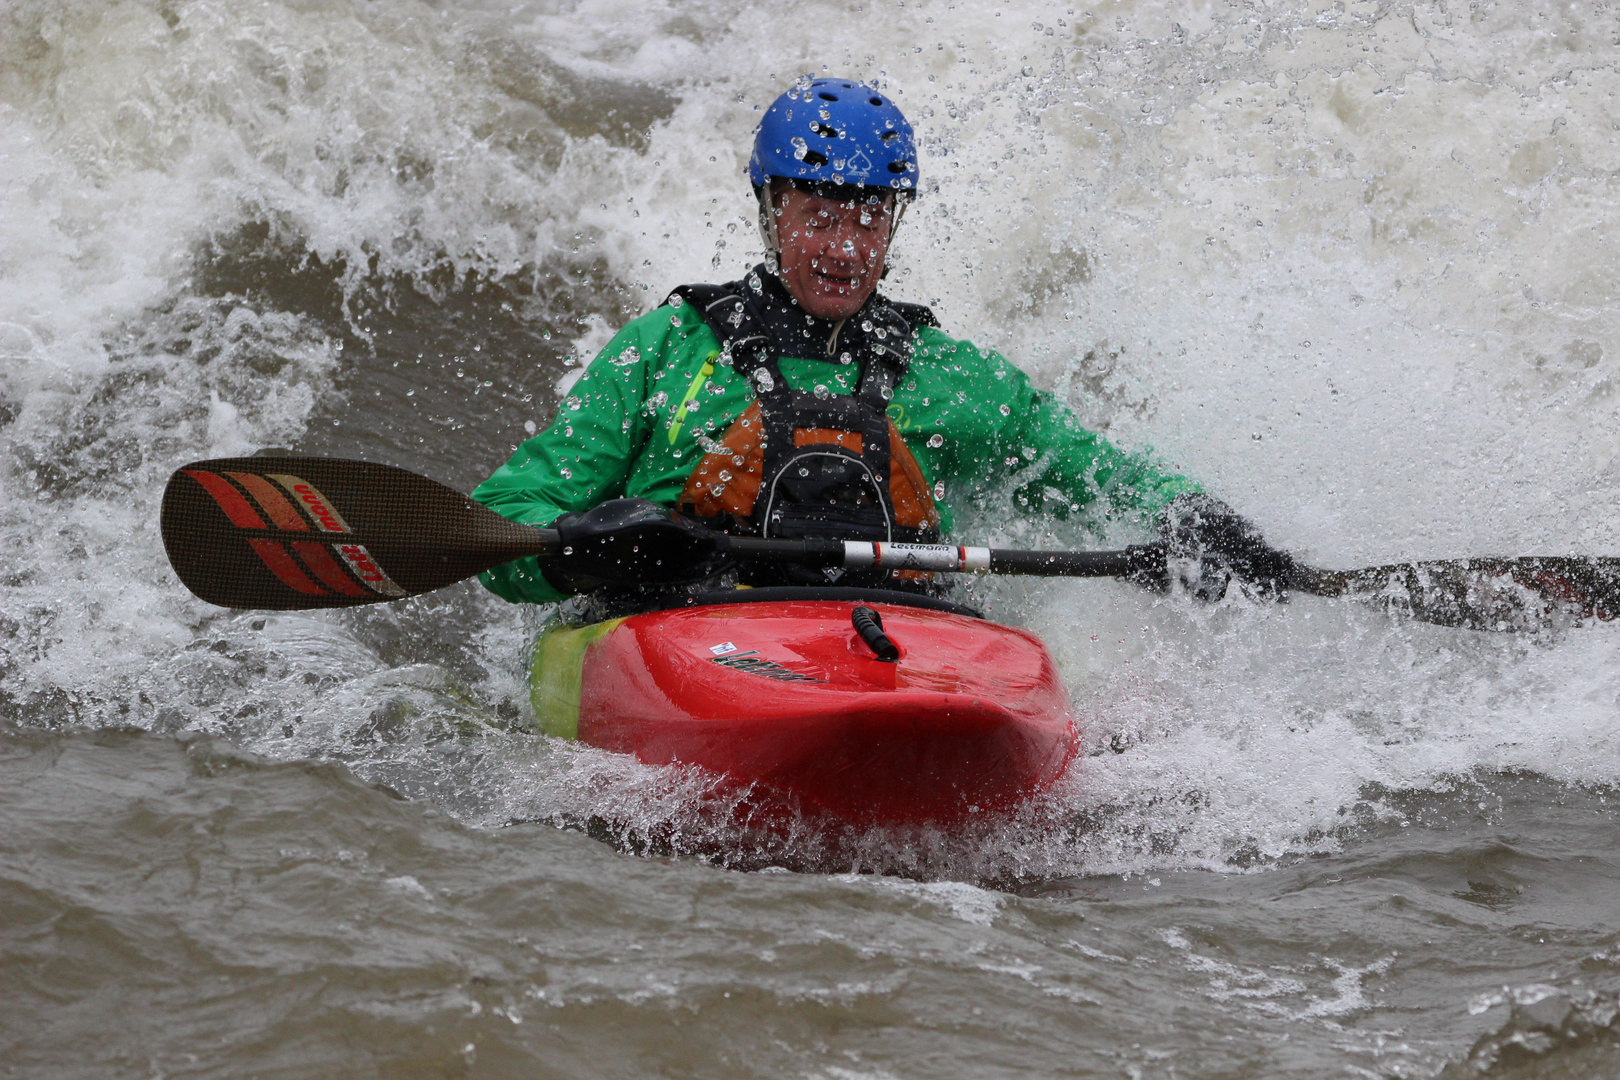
[162, 455, 1620, 630]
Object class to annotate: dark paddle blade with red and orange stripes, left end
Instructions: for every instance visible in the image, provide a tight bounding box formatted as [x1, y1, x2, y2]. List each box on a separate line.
[162, 455, 557, 610]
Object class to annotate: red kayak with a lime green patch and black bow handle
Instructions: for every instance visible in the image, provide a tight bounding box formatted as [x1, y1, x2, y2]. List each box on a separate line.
[531, 588, 1079, 824]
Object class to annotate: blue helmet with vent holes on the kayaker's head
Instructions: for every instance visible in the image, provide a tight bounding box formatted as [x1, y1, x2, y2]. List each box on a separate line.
[748, 79, 917, 193]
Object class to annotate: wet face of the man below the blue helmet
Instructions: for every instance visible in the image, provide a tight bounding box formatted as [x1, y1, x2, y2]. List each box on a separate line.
[771, 186, 894, 319]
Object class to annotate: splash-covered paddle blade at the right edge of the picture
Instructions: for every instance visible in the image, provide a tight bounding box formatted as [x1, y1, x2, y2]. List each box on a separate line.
[1298, 555, 1620, 630]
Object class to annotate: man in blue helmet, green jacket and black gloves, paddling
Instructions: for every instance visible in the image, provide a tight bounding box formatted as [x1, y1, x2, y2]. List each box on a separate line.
[473, 78, 1290, 602]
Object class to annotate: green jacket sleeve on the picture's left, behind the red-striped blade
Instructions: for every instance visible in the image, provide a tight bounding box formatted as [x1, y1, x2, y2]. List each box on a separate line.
[473, 320, 656, 604]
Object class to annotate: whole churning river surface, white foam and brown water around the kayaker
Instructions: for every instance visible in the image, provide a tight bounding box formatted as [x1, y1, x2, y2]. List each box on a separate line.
[0, 0, 1620, 1080]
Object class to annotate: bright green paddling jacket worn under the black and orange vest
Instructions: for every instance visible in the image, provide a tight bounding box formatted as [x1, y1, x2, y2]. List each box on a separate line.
[473, 303, 1196, 604]
